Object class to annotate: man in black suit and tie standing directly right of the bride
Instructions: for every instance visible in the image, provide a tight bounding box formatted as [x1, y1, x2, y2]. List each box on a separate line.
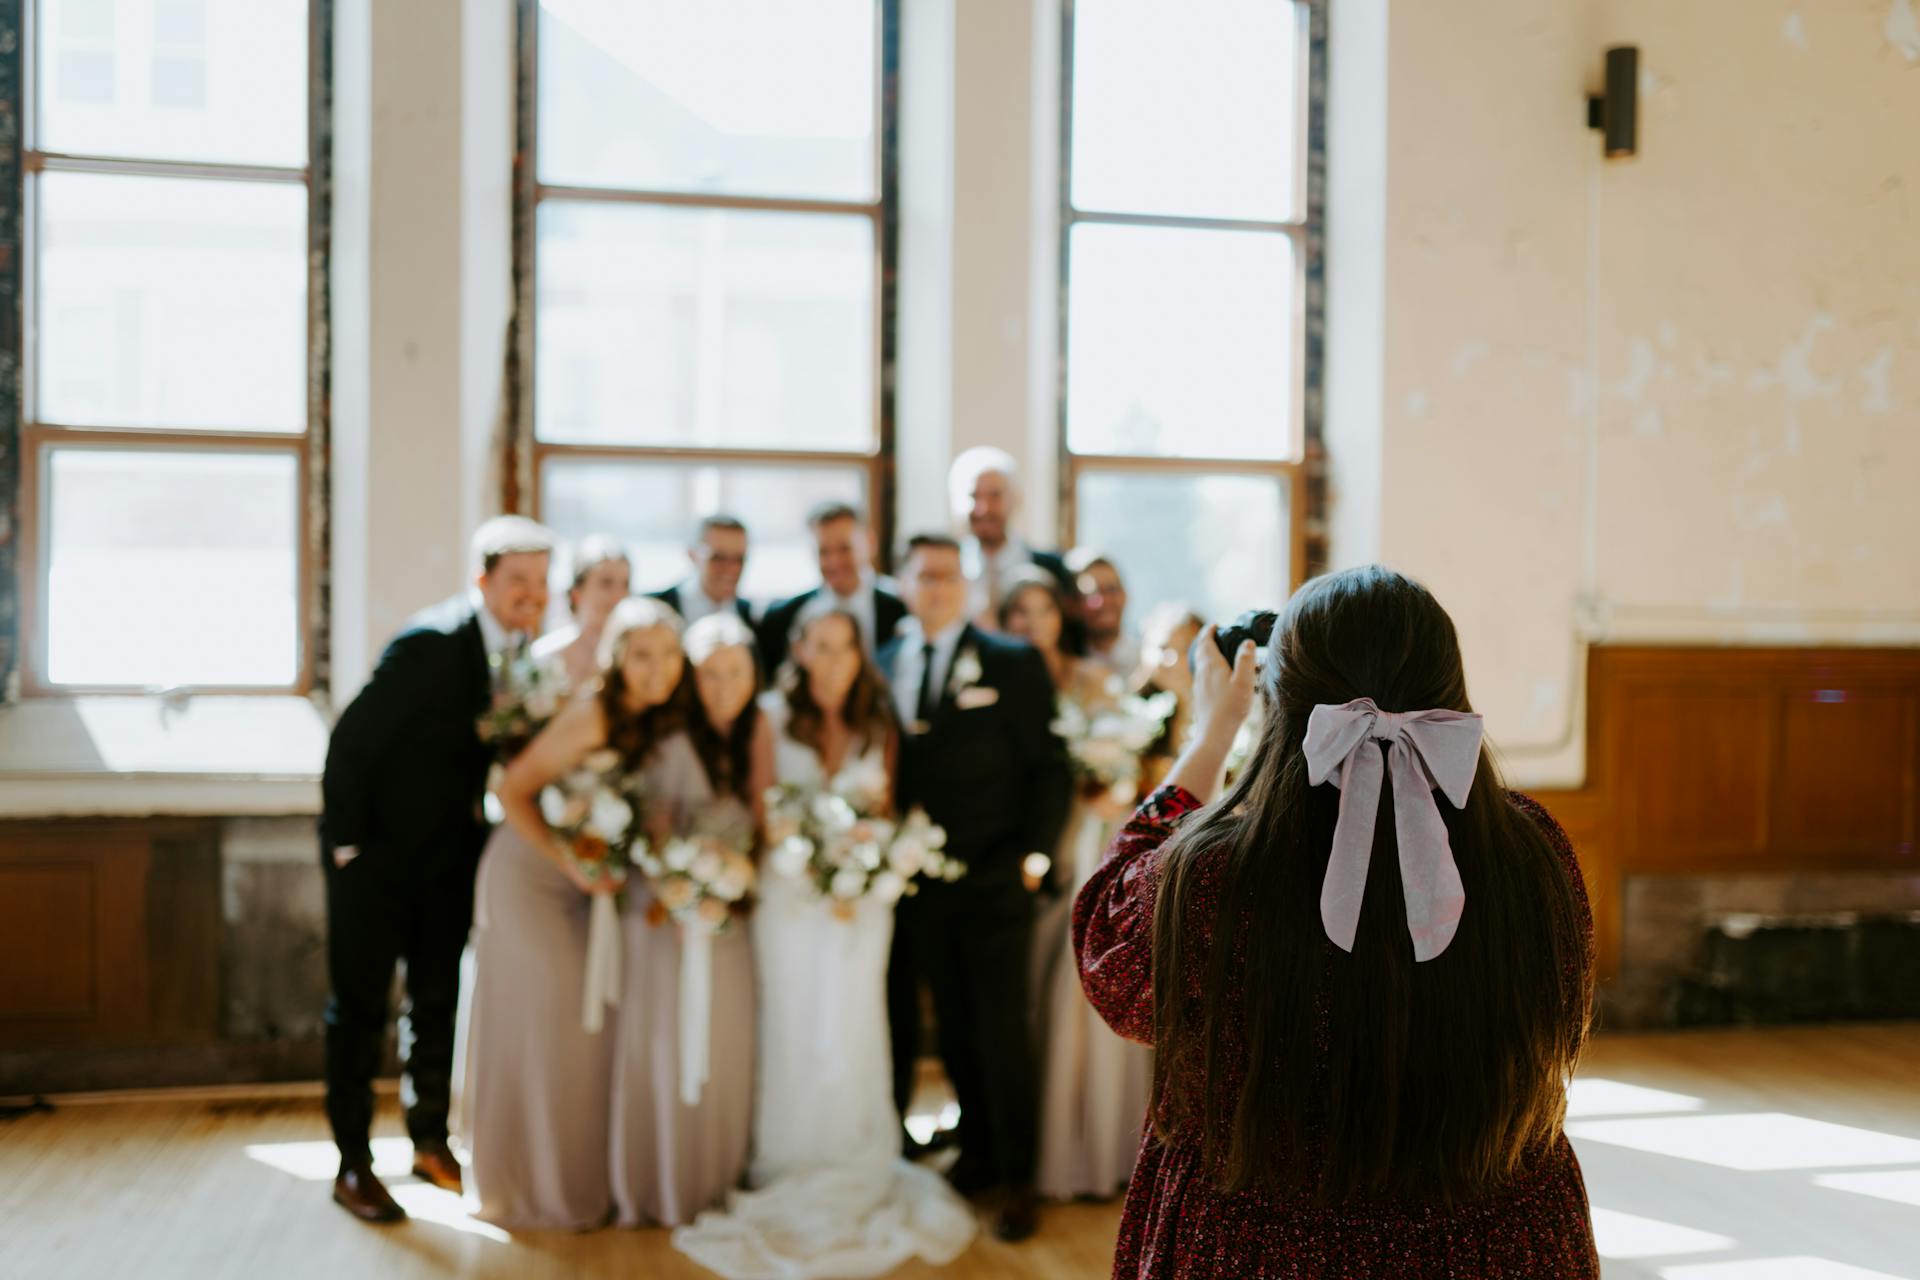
[879, 533, 1069, 1240]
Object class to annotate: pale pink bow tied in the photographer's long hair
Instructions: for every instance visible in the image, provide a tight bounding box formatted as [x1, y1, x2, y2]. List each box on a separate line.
[1306, 699, 1480, 960]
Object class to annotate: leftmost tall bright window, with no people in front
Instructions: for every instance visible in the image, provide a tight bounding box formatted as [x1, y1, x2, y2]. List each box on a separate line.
[21, 0, 313, 691]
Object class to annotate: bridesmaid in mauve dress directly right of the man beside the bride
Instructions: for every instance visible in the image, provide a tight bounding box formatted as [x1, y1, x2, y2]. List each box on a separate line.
[1000, 574, 1154, 1199]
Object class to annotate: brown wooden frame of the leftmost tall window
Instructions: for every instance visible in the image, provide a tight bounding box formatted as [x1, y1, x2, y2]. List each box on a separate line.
[0, 0, 332, 697]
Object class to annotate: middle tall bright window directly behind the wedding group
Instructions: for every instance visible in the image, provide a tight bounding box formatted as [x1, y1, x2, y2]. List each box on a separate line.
[528, 0, 895, 599]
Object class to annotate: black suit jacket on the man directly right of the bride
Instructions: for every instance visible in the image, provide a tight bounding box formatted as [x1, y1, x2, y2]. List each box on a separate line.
[879, 626, 1073, 892]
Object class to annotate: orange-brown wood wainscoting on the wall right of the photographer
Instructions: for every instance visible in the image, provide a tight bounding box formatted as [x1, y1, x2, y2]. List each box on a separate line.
[1534, 647, 1920, 979]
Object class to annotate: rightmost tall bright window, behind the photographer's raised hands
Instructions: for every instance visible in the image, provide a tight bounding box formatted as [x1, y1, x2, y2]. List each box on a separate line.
[1060, 0, 1309, 618]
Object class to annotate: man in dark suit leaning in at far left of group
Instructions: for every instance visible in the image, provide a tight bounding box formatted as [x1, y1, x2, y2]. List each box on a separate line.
[321, 516, 553, 1222]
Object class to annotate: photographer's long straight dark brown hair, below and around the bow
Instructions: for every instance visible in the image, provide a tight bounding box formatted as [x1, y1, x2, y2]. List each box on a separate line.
[1154, 566, 1592, 1203]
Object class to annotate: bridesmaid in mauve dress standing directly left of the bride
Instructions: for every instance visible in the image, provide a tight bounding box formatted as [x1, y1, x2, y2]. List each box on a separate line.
[612, 614, 774, 1226]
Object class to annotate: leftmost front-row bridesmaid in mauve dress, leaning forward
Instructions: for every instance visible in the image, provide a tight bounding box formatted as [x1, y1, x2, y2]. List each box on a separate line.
[465, 601, 685, 1230]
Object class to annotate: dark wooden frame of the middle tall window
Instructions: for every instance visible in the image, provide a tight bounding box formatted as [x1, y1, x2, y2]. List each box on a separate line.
[501, 0, 900, 570]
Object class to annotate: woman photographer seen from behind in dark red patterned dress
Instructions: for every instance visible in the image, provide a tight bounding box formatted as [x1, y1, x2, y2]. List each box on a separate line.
[1073, 568, 1599, 1280]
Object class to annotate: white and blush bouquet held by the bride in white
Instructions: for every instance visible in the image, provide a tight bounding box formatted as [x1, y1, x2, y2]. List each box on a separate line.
[766, 762, 966, 919]
